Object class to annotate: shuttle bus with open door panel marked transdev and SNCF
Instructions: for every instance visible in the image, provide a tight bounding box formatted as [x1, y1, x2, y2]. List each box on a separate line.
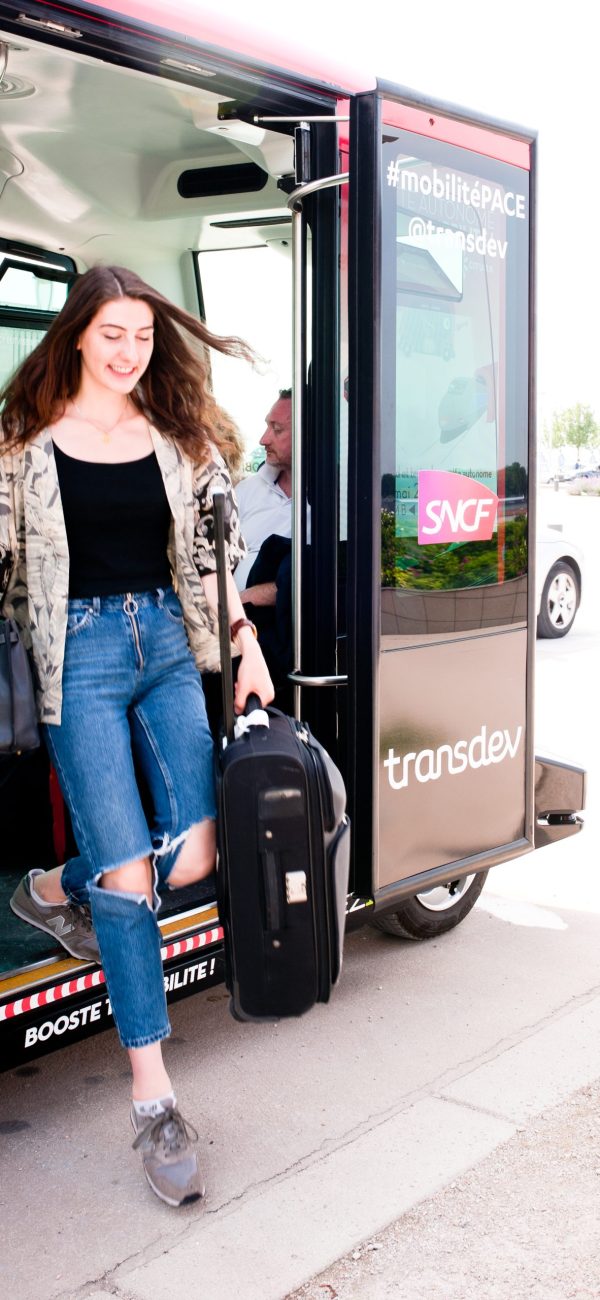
[0, 0, 584, 1067]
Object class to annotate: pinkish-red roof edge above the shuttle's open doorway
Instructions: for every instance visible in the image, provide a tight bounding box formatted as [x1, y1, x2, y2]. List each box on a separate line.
[52, 0, 377, 92]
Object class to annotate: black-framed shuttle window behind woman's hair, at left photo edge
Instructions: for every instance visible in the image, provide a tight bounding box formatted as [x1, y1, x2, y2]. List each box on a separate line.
[0, 256, 68, 387]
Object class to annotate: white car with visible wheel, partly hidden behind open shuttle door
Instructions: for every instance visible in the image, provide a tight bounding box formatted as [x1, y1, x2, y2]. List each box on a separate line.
[535, 528, 583, 637]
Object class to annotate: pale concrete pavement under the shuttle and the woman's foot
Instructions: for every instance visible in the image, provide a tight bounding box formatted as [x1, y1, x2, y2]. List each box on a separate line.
[0, 488, 600, 1300]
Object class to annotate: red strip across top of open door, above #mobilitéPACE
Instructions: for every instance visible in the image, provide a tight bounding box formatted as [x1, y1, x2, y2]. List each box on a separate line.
[383, 99, 531, 172]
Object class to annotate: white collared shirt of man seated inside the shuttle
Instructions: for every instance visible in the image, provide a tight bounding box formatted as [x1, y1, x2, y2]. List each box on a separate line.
[234, 462, 292, 592]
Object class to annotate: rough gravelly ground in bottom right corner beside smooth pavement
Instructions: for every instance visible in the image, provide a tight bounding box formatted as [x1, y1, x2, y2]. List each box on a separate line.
[287, 1082, 600, 1300]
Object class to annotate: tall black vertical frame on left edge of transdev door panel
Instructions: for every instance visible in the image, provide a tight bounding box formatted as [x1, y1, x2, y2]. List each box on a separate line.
[347, 94, 381, 896]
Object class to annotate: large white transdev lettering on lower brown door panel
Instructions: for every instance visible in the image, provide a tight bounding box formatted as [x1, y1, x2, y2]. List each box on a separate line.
[383, 727, 523, 790]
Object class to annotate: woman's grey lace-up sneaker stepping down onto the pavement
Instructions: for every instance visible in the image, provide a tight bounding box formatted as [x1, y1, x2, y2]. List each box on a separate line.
[131, 1100, 204, 1205]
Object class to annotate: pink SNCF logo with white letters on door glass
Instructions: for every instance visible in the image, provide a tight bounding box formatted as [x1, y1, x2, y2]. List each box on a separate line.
[418, 469, 497, 546]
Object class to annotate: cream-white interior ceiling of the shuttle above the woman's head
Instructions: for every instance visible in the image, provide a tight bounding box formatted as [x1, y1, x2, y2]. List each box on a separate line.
[0, 34, 292, 256]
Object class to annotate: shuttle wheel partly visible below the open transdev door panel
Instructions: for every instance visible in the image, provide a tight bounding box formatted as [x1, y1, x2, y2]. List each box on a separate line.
[371, 871, 487, 939]
